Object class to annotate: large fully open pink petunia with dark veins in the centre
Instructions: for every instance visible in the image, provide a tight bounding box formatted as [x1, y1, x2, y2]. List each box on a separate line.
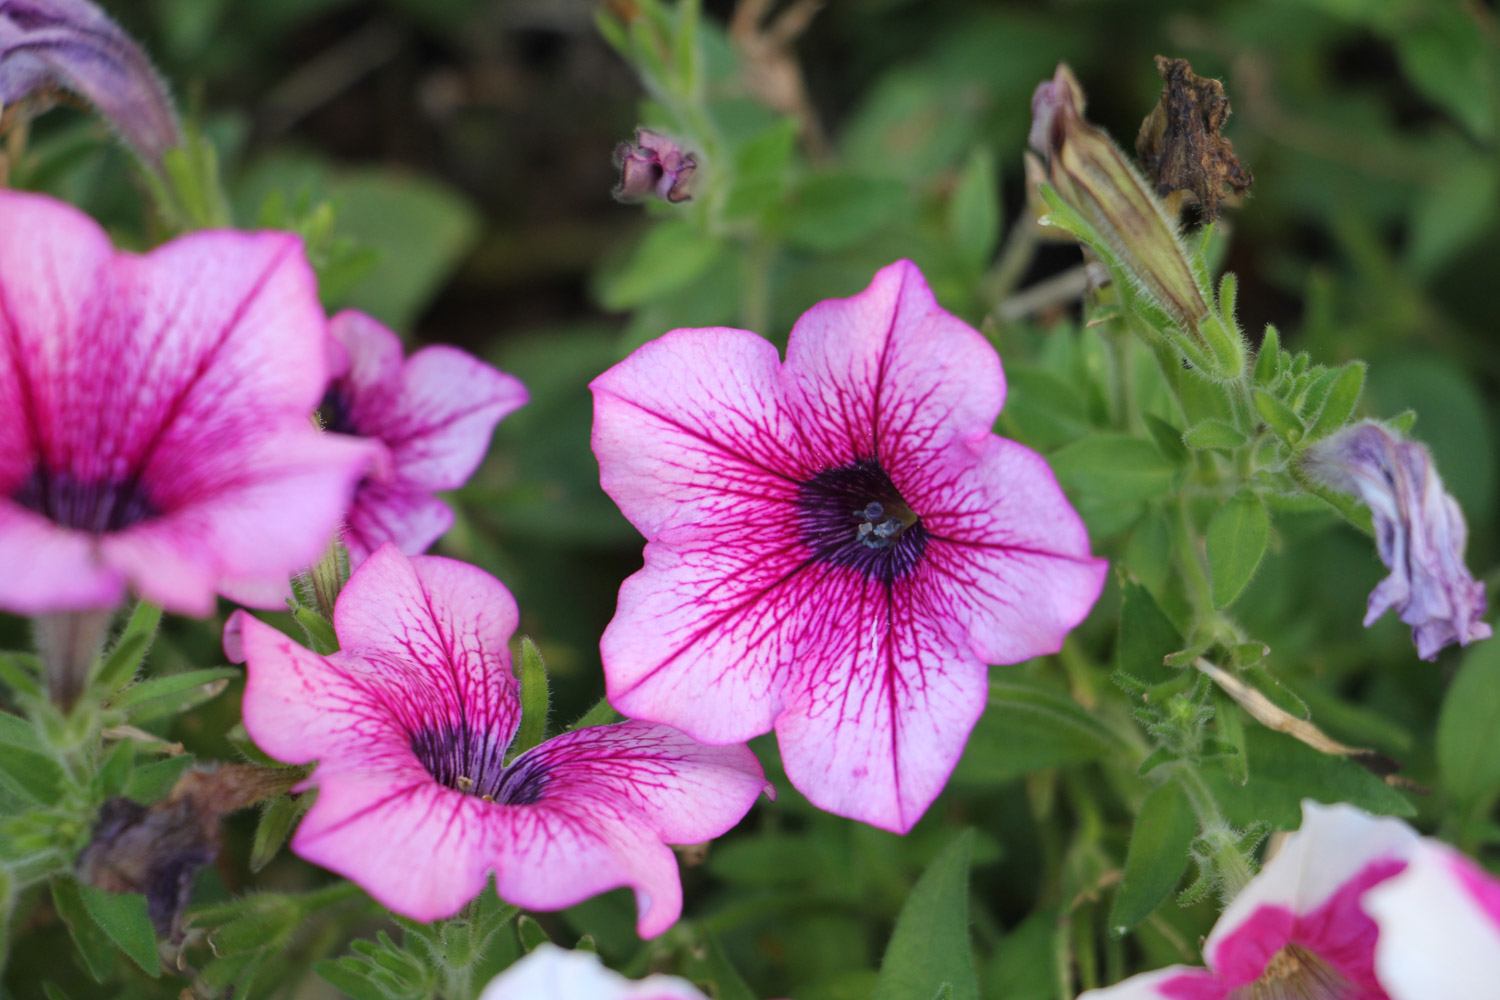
[593, 261, 1106, 832]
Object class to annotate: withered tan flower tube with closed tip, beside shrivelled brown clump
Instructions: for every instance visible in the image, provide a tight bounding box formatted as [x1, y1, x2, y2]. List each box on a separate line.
[1029, 64, 1244, 378]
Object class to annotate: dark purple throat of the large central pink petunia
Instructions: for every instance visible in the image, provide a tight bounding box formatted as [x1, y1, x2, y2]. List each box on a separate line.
[797, 459, 927, 585]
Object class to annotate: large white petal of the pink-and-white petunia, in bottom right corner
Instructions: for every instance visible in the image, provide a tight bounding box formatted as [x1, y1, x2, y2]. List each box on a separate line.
[1365, 840, 1500, 1000]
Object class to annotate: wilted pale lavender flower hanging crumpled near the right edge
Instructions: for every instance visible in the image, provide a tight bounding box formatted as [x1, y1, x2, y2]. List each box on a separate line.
[1304, 421, 1491, 660]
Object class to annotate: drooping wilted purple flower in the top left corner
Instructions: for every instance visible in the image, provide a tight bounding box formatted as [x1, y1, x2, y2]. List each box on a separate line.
[0, 0, 183, 166]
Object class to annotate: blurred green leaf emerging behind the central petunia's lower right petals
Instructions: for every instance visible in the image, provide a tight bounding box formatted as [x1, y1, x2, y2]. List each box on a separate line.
[953, 681, 1121, 787]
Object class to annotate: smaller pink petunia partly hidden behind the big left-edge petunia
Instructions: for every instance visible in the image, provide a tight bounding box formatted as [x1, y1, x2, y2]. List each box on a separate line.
[318, 312, 527, 565]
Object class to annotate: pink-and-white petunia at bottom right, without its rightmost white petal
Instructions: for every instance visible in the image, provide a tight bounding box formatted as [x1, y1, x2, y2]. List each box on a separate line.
[1079, 801, 1416, 1000]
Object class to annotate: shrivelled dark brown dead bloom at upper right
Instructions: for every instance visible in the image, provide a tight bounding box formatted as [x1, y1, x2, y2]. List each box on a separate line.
[1136, 55, 1254, 222]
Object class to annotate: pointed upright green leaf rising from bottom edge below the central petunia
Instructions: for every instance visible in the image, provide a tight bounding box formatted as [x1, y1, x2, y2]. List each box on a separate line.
[875, 831, 980, 1000]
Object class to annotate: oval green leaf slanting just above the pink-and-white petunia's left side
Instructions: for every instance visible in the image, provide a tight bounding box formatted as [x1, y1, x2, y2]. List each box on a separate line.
[1110, 781, 1199, 934]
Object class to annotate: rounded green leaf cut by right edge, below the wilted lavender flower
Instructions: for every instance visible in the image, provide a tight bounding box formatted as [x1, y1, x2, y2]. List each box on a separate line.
[1437, 640, 1500, 813]
